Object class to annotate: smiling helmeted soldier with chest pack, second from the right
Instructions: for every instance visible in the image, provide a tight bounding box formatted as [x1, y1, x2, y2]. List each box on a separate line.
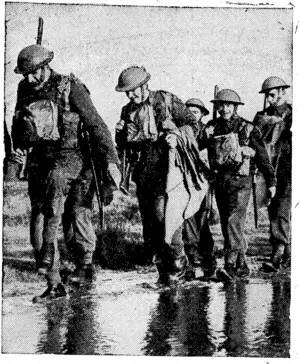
[204, 89, 276, 281]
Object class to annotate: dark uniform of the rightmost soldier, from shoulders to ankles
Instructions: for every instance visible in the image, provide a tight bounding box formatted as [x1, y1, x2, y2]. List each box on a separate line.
[253, 102, 292, 259]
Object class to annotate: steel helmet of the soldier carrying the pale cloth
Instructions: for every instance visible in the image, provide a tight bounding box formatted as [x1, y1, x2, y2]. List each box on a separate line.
[116, 66, 151, 92]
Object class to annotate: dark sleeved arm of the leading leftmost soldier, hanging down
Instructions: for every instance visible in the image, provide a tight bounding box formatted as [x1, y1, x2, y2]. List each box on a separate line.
[70, 81, 118, 163]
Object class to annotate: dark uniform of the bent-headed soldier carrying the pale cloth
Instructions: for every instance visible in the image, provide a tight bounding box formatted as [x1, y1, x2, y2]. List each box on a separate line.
[116, 91, 197, 278]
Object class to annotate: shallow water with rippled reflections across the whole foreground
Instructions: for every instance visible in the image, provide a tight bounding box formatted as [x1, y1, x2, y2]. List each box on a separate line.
[2, 270, 290, 357]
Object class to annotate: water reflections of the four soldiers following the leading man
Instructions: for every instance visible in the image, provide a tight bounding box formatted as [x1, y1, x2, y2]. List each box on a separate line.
[144, 280, 290, 357]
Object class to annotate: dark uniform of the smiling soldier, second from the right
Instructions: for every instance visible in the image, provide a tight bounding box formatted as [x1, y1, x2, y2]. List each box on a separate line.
[206, 113, 275, 272]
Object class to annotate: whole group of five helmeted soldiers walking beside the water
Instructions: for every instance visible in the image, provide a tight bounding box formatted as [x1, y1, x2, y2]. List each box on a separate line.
[8, 45, 292, 301]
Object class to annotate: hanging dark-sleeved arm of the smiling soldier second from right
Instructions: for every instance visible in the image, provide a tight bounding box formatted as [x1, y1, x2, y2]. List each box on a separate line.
[249, 126, 276, 187]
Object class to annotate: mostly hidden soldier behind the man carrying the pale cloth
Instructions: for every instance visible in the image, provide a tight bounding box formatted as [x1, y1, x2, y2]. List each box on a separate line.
[183, 98, 216, 278]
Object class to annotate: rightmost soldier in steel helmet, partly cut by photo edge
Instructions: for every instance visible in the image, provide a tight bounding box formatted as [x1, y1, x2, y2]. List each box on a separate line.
[253, 76, 292, 272]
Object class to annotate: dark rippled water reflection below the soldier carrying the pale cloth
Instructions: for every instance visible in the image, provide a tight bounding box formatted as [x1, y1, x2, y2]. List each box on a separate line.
[143, 287, 215, 356]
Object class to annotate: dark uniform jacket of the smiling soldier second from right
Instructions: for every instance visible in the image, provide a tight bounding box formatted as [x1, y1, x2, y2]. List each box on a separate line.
[201, 114, 276, 187]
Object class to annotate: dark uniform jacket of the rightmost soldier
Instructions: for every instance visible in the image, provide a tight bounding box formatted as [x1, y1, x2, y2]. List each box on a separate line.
[253, 103, 292, 183]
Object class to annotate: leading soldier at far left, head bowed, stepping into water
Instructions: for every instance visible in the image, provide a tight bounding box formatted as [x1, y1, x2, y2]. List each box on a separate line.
[12, 45, 120, 301]
